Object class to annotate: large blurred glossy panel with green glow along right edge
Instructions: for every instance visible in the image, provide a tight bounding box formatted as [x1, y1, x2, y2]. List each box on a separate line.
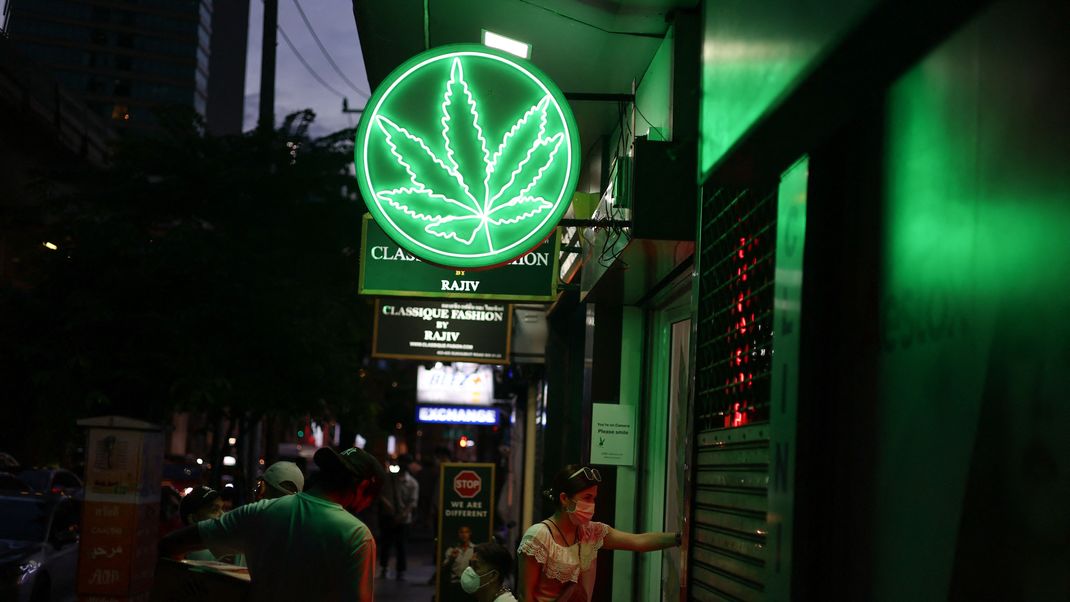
[868, 2, 1070, 601]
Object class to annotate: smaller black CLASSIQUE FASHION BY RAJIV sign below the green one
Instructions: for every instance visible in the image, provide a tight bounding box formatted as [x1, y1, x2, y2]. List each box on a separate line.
[371, 299, 513, 364]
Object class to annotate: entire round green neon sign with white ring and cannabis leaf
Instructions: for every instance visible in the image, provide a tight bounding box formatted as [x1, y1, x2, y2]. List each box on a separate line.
[355, 45, 580, 268]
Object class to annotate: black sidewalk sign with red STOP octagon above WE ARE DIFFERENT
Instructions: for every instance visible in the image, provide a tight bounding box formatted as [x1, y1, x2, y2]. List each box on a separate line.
[434, 463, 495, 602]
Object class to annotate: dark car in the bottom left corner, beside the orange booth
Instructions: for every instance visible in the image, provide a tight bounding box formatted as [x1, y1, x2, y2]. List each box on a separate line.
[0, 493, 79, 602]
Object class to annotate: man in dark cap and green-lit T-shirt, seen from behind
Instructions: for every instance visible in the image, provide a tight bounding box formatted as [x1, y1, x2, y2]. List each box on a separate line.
[159, 447, 386, 602]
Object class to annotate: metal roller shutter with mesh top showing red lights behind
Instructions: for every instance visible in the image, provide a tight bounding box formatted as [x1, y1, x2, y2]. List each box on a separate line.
[688, 189, 777, 600]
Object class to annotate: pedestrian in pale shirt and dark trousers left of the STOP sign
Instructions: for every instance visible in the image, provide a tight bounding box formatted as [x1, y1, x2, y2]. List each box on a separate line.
[379, 454, 419, 581]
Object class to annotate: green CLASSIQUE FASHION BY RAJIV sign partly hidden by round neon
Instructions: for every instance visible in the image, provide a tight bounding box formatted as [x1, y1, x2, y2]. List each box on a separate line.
[358, 215, 560, 302]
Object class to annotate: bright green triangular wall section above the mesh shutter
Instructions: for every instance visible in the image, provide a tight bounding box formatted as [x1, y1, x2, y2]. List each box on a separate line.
[699, 0, 874, 173]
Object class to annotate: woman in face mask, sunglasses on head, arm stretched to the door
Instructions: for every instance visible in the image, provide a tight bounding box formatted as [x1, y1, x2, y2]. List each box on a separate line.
[518, 465, 681, 602]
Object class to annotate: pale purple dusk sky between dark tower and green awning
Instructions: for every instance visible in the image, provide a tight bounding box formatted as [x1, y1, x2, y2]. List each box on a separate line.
[244, 0, 368, 136]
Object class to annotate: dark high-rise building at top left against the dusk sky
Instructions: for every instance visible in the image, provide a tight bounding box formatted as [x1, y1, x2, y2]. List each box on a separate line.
[5, 0, 248, 132]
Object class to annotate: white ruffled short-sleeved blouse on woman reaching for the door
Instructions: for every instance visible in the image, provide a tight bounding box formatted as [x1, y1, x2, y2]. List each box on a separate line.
[517, 521, 609, 602]
